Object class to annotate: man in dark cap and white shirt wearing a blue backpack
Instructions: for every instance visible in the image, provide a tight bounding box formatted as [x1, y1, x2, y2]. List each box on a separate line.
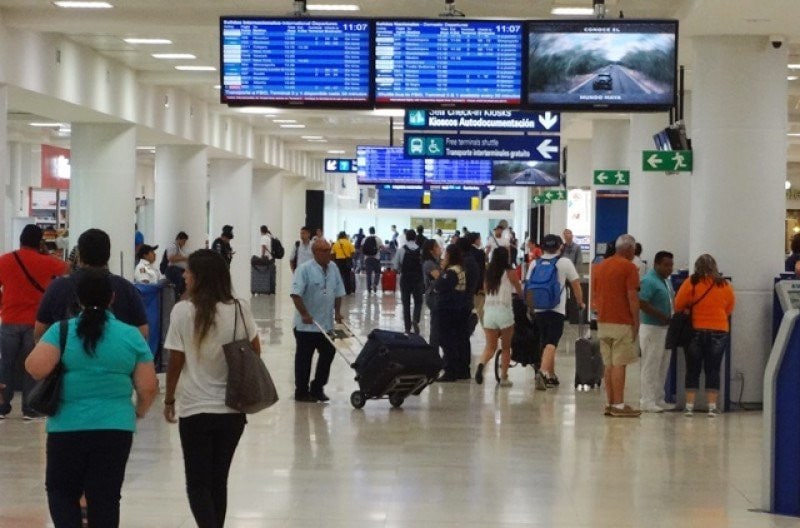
[526, 235, 583, 390]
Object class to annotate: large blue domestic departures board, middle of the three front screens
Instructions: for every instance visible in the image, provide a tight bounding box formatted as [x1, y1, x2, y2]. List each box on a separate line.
[375, 20, 523, 106]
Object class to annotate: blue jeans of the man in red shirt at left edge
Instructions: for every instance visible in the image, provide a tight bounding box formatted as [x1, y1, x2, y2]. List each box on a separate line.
[0, 324, 37, 415]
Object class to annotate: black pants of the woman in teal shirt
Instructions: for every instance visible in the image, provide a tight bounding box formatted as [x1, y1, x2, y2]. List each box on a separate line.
[45, 430, 133, 528]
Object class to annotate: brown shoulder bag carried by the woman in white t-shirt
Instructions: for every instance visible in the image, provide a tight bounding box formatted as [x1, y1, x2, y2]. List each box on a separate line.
[222, 300, 278, 414]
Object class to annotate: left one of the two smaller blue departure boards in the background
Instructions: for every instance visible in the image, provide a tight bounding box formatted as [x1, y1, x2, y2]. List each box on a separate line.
[356, 146, 425, 185]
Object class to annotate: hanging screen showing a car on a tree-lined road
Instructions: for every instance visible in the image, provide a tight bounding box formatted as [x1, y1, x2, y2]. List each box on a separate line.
[527, 19, 678, 111]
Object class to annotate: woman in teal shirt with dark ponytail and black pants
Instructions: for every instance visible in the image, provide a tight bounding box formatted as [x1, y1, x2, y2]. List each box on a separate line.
[25, 269, 158, 528]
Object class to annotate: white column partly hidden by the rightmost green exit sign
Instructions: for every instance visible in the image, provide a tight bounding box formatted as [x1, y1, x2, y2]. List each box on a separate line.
[628, 114, 691, 269]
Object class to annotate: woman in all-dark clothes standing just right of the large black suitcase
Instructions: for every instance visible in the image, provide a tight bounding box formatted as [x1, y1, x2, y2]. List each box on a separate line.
[434, 244, 472, 382]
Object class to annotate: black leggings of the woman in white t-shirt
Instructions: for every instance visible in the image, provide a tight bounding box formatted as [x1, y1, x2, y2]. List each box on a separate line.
[180, 413, 247, 528]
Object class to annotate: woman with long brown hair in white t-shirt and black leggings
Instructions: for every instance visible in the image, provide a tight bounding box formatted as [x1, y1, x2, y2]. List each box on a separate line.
[164, 249, 261, 528]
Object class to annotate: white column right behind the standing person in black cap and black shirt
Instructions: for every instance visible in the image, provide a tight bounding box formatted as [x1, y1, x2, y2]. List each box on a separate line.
[209, 159, 252, 298]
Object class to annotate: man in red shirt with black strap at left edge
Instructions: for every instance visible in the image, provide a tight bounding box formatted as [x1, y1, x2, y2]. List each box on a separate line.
[0, 224, 69, 419]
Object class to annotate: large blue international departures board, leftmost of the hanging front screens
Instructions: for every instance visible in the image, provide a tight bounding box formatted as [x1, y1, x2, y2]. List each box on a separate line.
[220, 17, 372, 106]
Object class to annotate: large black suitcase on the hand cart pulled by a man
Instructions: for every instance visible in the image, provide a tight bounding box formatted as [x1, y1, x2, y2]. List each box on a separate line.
[353, 329, 443, 398]
